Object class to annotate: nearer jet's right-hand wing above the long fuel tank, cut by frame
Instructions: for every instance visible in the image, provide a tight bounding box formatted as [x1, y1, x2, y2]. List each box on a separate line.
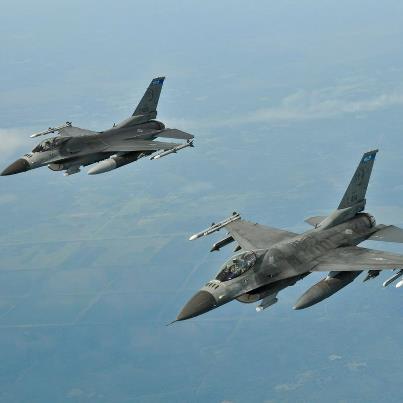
[311, 246, 403, 271]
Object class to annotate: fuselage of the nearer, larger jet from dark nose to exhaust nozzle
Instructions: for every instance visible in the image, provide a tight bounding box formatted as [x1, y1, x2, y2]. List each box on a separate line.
[177, 213, 376, 320]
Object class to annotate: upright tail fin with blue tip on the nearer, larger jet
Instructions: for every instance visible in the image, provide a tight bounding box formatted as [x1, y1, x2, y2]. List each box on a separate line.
[337, 150, 378, 210]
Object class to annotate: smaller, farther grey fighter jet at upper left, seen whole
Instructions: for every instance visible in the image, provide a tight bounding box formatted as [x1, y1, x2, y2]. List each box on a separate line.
[1, 77, 193, 176]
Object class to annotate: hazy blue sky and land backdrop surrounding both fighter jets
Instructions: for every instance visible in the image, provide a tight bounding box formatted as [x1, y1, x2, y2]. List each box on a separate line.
[0, 0, 403, 402]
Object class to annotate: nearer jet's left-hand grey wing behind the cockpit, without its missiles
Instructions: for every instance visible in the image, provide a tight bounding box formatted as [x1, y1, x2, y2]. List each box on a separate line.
[225, 220, 298, 250]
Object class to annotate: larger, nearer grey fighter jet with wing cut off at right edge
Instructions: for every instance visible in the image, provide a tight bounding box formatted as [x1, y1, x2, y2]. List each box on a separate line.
[176, 150, 403, 321]
